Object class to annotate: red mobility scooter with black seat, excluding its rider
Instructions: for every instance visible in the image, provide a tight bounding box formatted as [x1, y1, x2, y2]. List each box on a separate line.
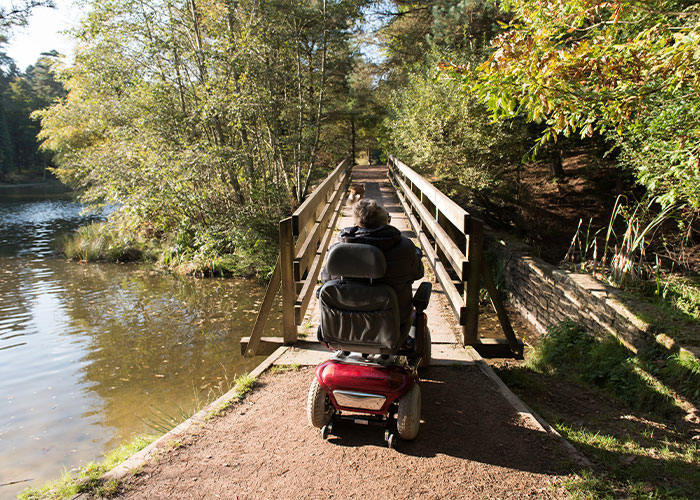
[306, 243, 432, 448]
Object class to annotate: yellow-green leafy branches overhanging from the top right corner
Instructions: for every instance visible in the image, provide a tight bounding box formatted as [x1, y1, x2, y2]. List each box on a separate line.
[465, 0, 700, 211]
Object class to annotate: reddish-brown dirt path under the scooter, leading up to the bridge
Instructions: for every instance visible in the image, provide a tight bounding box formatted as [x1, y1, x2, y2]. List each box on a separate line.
[115, 367, 567, 499]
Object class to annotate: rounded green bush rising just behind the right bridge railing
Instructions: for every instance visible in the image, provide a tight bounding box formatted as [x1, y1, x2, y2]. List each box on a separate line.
[387, 52, 525, 200]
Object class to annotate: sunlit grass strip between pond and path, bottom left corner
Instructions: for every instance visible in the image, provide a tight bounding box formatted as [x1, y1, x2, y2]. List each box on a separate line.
[19, 436, 156, 500]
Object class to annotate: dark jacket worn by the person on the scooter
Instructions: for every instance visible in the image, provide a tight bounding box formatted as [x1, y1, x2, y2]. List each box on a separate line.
[324, 225, 423, 332]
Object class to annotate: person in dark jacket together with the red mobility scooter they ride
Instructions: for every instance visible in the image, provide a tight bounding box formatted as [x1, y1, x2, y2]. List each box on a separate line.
[307, 199, 432, 447]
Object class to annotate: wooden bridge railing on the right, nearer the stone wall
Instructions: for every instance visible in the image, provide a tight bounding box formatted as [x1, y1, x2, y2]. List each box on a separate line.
[388, 156, 523, 357]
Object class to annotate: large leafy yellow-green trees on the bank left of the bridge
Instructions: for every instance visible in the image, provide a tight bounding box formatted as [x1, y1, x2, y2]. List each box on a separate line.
[37, 0, 362, 274]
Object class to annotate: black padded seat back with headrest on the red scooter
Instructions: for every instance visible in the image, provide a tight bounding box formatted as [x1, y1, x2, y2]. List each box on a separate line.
[319, 243, 405, 354]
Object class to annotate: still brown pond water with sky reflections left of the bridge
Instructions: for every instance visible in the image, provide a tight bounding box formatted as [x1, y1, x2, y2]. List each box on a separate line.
[0, 188, 279, 498]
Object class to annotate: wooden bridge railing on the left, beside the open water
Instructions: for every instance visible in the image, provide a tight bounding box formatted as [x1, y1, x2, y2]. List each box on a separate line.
[241, 156, 353, 356]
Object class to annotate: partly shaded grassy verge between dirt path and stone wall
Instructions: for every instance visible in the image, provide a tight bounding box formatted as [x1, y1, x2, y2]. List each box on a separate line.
[497, 323, 700, 499]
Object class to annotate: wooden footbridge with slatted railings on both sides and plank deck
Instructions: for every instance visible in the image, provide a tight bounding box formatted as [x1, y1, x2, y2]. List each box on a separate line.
[241, 156, 523, 364]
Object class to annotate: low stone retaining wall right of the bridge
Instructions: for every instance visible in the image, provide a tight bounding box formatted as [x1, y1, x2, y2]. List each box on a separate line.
[494, 239, 653, 352]
